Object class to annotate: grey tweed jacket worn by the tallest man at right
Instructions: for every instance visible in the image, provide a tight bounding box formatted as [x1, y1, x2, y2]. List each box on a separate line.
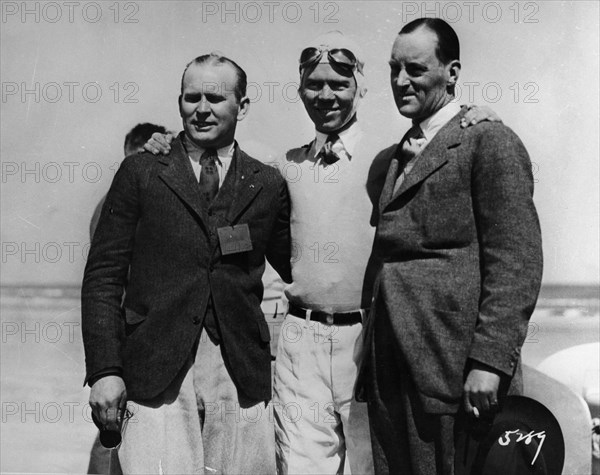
[360, 112, 542, 413]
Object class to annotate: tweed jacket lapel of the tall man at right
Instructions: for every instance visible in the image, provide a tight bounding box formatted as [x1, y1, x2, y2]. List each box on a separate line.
[383, 111, 464, 209]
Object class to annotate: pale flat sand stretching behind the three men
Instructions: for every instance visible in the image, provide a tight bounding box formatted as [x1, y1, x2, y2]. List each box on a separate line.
[0, 287, 600, 473]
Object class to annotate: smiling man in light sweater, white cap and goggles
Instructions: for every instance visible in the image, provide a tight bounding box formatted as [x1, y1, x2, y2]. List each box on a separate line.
[146, 32, 500, 474]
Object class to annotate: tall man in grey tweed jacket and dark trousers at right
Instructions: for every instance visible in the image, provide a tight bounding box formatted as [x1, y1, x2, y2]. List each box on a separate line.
[358, 18, 542, 475]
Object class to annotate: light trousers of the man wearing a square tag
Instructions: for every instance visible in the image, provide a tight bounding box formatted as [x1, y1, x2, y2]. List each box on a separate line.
[119, 332, 275, 475]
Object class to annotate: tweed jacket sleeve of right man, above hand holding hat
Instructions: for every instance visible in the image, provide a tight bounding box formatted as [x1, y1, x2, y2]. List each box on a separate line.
[469, 124, 542, 376]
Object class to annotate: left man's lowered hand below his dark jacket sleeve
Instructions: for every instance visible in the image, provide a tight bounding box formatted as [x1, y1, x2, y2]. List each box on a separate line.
[90, 375, 127, 431]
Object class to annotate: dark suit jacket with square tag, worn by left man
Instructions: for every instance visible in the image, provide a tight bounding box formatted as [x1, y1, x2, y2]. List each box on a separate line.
[82, 139, 291, 400]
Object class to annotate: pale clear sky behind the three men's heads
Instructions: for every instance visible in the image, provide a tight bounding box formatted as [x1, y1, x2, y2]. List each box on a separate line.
[1, 1, 600, 284]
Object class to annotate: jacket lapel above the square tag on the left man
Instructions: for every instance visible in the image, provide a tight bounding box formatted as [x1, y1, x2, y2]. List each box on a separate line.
[215, 142, 262, 224]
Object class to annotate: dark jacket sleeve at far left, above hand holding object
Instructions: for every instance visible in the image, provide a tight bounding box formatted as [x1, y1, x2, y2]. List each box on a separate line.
[81, 158, 139, 382]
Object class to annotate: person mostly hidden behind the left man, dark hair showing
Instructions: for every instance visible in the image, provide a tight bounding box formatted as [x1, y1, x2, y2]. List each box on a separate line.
[88, 122, 167, 475]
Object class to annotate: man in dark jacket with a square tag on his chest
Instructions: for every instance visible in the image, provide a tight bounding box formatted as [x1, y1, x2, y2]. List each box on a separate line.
[82, 54, 291, 473]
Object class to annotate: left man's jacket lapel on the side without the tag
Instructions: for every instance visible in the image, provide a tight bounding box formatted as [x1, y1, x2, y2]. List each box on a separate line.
[159, 138, 208, 231]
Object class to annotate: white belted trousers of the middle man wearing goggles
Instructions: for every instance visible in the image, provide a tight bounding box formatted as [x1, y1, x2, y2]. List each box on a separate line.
[273, 314, 373, 475]
